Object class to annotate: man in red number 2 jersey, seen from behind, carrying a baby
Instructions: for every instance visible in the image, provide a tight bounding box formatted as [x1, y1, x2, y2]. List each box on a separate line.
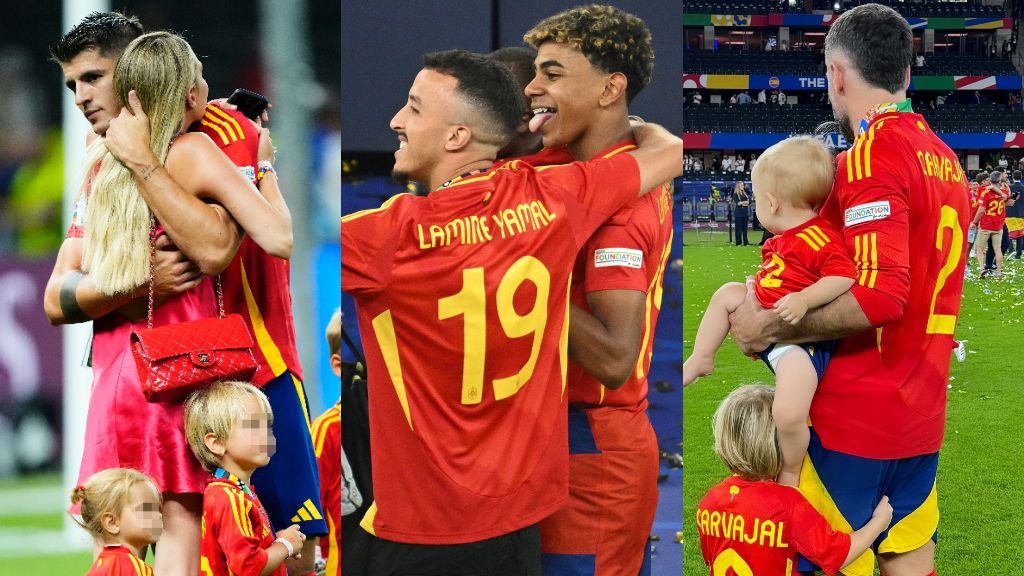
[730, 4, 970, 576]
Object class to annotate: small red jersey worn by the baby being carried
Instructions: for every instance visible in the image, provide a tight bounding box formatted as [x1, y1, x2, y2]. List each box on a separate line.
[754, 216, 857, 308]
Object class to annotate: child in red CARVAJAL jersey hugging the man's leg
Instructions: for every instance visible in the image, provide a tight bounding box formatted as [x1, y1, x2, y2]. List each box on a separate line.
[696, 384, 893, 575]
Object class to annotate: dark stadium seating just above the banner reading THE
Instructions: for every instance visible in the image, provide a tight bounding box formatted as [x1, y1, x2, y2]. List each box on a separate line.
[683, 49, 1017, 76]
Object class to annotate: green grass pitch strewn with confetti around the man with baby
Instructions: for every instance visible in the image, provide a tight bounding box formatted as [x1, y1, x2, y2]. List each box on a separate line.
[683, 232, 1024, 576]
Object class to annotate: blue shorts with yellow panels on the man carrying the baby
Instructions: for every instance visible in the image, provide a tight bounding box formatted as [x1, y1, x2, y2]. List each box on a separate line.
[797, 426, 939, 576]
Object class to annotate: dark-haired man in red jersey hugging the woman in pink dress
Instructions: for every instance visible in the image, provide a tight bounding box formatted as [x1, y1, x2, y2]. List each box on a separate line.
[45, 12, 327, 575]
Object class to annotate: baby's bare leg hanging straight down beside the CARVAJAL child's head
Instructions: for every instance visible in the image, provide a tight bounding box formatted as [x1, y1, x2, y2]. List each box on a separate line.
[771, 347, 818, 486]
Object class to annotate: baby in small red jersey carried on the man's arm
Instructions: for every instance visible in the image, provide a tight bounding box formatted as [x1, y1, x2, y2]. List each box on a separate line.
[683, 136, 857, 486]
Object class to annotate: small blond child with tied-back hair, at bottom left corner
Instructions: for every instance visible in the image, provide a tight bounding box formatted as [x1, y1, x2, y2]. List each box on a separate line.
[71, 468, 164, 576]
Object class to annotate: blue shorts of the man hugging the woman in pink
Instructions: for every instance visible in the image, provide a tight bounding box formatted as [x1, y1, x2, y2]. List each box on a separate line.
[252, 371, 325, 536]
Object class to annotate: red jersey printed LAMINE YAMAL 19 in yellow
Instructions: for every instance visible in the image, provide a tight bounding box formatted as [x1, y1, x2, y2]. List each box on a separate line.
[341, 154, 640, 544]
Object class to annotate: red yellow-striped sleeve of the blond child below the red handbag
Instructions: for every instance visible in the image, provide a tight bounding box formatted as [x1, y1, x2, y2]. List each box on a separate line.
[206, 487, 267, 576]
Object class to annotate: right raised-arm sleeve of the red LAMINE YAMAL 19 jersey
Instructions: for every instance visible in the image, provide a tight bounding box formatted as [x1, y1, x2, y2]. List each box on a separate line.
[538, 154, 640, 246]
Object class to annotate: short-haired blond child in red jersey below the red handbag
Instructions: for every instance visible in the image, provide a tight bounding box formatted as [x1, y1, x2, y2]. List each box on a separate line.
[185, 381, 305, 576]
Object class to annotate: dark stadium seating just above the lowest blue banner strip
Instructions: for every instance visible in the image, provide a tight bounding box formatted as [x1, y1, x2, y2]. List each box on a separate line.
[683, 104, 1024, 133]
